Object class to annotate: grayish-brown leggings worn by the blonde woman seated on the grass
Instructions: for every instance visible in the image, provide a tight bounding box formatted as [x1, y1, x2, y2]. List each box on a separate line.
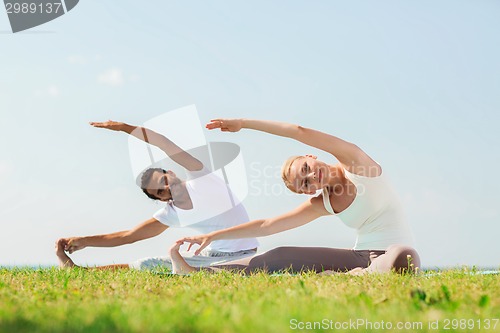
[212, 245, 420, 273]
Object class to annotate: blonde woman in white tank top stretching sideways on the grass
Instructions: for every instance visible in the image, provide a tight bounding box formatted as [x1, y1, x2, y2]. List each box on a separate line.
[178, 119, 420, 273]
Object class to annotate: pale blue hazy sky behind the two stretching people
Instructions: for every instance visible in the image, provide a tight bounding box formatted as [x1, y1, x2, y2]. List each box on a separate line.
[0, 0, 500, 267]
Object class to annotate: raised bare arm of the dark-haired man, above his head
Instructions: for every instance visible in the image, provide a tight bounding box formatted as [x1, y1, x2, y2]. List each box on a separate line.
[90, 120, 203, 171]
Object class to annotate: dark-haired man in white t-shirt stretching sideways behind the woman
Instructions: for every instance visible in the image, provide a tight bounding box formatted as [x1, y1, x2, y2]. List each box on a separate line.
[56, 120, 258, 269]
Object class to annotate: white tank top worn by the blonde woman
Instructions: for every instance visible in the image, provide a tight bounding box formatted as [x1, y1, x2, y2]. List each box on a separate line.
[323, 169, 413, 250]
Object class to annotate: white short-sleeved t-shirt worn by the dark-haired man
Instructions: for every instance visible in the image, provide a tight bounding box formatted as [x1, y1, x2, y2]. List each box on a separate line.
[153, 169, 259, 252]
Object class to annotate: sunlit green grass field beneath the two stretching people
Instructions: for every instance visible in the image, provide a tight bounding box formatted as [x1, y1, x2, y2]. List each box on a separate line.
[0, 269, 500, 333]
